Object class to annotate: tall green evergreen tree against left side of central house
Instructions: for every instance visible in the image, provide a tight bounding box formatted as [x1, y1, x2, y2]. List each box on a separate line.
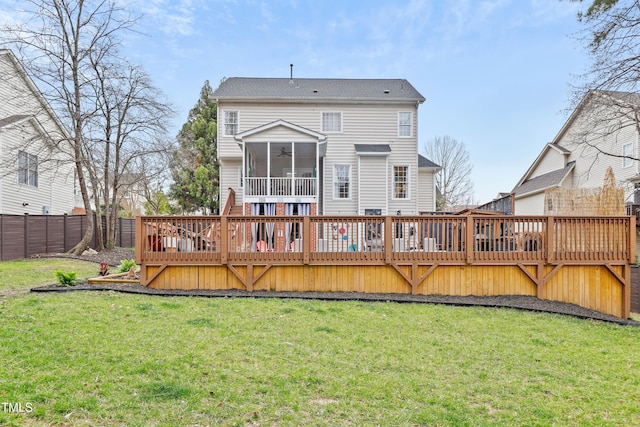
[170, 80, 220, 215]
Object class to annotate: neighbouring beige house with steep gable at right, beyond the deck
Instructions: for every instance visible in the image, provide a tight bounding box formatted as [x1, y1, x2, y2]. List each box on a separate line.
[513, 92, 640, 215]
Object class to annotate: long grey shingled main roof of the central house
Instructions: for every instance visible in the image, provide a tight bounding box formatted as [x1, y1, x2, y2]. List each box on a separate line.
[212, 77, 425, 103]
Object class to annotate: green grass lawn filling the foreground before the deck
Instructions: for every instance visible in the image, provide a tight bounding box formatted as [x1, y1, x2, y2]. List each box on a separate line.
[0, 263, 640, 426]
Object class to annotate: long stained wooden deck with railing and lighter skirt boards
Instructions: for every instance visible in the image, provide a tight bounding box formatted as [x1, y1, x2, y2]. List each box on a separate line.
[136, 215, 635, 318]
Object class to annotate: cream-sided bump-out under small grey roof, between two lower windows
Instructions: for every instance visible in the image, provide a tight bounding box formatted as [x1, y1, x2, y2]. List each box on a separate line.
[358, 156, 389, 215]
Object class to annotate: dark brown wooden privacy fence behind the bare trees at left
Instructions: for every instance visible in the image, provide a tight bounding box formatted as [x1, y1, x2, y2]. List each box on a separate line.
[0, 215, 135, 261]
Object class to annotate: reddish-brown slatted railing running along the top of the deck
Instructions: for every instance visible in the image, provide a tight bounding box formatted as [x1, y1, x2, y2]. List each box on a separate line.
[136, 216, 635, 264]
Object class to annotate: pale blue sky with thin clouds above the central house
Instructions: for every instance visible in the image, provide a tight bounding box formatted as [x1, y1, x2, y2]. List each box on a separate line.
[2, 0, 587, 202]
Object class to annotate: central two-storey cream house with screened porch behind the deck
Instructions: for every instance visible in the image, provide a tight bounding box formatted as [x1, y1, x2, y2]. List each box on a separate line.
[213, 78, 440, 221]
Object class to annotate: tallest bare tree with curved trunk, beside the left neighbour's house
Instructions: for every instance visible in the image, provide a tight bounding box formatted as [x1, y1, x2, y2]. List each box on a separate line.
[3, 0, 136, 254]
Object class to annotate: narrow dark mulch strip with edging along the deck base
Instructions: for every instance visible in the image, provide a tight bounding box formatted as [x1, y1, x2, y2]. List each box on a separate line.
[31, 282, 640, 326]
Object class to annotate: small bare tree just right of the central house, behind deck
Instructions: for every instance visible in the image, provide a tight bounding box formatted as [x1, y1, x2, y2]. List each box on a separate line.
[423, 135, 473, 210]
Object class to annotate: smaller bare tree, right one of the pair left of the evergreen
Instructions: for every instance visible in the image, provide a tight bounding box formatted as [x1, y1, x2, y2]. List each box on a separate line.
[88, 61, 173, 247]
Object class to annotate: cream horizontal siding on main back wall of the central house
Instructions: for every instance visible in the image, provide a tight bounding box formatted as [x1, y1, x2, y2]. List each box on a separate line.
[218, 101, 418, 215]
